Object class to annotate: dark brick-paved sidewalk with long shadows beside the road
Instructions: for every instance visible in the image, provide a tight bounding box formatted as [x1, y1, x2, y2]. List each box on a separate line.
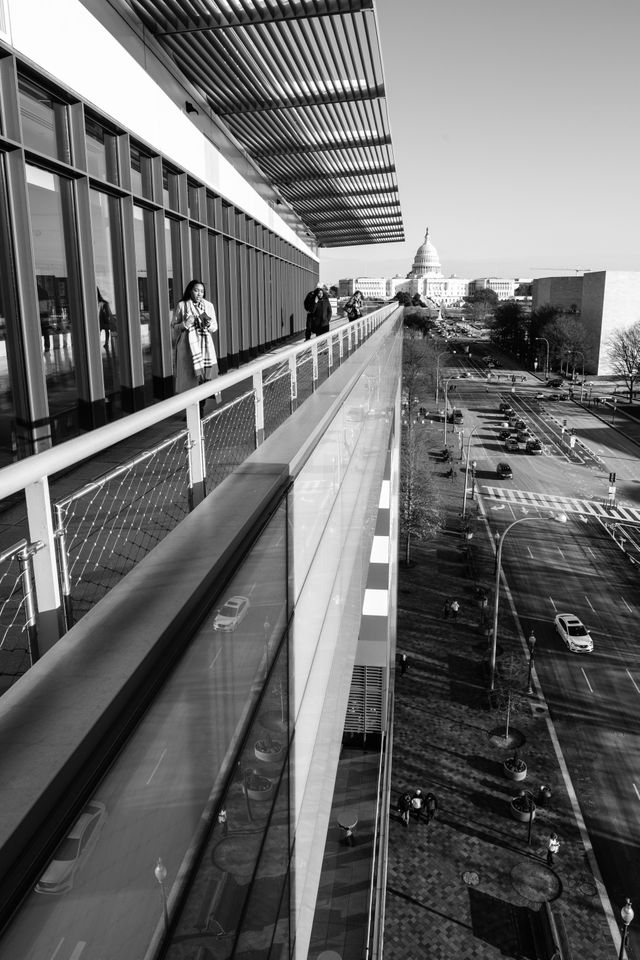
[384, 426, 617, 960]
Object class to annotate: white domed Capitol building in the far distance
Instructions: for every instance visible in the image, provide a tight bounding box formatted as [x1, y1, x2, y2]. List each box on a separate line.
[338, 227, 531, 307]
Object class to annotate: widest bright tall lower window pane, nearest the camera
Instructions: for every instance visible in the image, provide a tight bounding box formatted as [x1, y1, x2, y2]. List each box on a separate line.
[26, 164, 78, 416]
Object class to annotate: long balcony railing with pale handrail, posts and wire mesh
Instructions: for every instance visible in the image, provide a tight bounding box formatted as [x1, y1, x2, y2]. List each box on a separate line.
[0, 304, 398, 692]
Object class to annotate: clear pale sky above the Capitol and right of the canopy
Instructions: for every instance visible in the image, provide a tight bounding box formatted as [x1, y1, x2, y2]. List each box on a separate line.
[320, 0, 640, 283]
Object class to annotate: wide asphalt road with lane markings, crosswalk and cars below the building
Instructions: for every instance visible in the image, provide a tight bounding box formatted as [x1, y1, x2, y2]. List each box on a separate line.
[447, 357, 640, 957]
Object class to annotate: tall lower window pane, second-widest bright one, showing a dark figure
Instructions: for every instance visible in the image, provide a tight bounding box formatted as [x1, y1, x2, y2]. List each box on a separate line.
[90, 190, 120, 399]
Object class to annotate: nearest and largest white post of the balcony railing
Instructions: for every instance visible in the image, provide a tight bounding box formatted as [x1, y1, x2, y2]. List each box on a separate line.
[24, 477, 64, 653]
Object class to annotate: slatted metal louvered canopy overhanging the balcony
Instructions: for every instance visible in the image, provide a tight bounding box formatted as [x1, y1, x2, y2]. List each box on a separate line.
[129, 0, 404, 247]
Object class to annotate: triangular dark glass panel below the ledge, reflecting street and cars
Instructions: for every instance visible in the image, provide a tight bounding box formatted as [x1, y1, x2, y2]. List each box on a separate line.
[0, 503, 289, 960]
